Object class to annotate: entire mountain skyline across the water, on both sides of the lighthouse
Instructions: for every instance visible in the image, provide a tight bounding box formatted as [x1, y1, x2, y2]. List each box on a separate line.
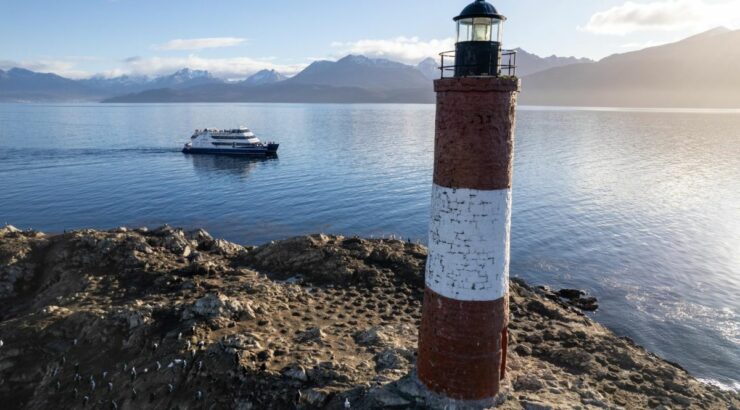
[0, 28, 740, 108]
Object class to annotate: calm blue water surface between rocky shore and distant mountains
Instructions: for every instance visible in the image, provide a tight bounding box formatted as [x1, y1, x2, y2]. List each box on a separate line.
[0, 104, 740, 389]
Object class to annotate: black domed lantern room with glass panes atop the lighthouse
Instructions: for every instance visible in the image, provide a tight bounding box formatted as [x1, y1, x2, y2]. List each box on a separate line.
[453, 0, 506, 77]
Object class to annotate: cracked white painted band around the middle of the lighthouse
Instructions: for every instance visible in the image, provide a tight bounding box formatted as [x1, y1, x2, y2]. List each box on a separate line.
[426, 184, 511, 301]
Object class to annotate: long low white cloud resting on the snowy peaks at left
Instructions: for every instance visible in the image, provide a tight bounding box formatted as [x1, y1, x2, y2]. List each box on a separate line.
[119, 54, 307, 79]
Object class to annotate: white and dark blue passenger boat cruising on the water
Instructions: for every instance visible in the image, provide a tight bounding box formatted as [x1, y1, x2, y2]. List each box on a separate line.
[182, 127, 280, 157]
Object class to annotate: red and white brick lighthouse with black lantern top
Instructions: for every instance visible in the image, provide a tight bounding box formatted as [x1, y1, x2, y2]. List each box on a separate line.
[417, 0, 520, 407]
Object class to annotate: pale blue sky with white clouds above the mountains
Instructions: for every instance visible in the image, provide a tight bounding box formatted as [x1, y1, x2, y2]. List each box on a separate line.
[0, 0, 740, 79]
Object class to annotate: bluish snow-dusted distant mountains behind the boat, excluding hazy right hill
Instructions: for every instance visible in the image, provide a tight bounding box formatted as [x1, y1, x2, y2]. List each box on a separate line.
[0, 45, 588, 103]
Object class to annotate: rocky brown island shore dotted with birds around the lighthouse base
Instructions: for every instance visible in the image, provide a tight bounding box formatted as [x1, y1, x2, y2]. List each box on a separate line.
[0, 226, 740, 410]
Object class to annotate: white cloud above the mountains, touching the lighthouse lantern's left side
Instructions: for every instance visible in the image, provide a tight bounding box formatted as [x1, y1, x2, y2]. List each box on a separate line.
[331, 37, 455, 64]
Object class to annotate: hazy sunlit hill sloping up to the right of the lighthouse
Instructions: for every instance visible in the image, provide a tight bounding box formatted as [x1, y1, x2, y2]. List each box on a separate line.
[520, 28, 740, 108]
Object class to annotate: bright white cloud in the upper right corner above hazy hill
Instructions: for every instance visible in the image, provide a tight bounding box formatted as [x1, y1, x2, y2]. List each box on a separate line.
[579, 0, 740, 35]
